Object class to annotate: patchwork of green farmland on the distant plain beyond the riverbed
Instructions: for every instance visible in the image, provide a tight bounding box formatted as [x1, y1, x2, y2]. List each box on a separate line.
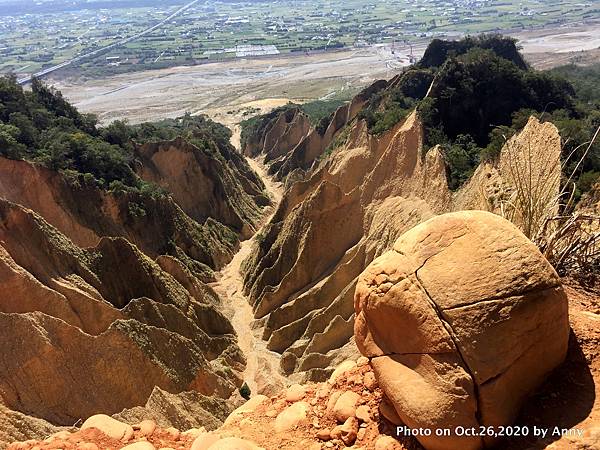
[0, 0, 600, 76]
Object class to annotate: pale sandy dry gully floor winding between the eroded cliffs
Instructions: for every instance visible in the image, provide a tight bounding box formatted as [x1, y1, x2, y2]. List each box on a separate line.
[211, 136, 289, 395]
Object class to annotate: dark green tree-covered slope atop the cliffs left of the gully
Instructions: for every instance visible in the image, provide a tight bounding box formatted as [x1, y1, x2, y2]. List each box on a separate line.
[0, 77, 241, 195]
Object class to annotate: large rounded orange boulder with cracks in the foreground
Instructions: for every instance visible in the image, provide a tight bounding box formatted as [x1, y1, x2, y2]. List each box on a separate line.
[354, 211, 569, 450]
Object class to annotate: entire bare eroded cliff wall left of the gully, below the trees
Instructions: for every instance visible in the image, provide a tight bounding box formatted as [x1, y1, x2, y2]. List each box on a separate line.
[0, 132, 270, 446]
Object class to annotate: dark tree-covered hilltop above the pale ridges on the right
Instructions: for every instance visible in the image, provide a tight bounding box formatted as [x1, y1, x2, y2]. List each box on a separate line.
[359, 35, 600, 196]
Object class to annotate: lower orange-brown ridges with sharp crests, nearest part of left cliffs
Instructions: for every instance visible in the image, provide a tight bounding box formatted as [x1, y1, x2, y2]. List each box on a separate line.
[0, 200, 245, 432]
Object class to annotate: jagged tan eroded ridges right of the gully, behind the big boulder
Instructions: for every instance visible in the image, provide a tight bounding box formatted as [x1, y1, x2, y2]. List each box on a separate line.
[244, 96, 560, 380]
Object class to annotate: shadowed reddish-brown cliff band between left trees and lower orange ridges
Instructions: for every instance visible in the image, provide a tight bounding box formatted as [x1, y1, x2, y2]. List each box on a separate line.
[0, 158, 238, 278]
